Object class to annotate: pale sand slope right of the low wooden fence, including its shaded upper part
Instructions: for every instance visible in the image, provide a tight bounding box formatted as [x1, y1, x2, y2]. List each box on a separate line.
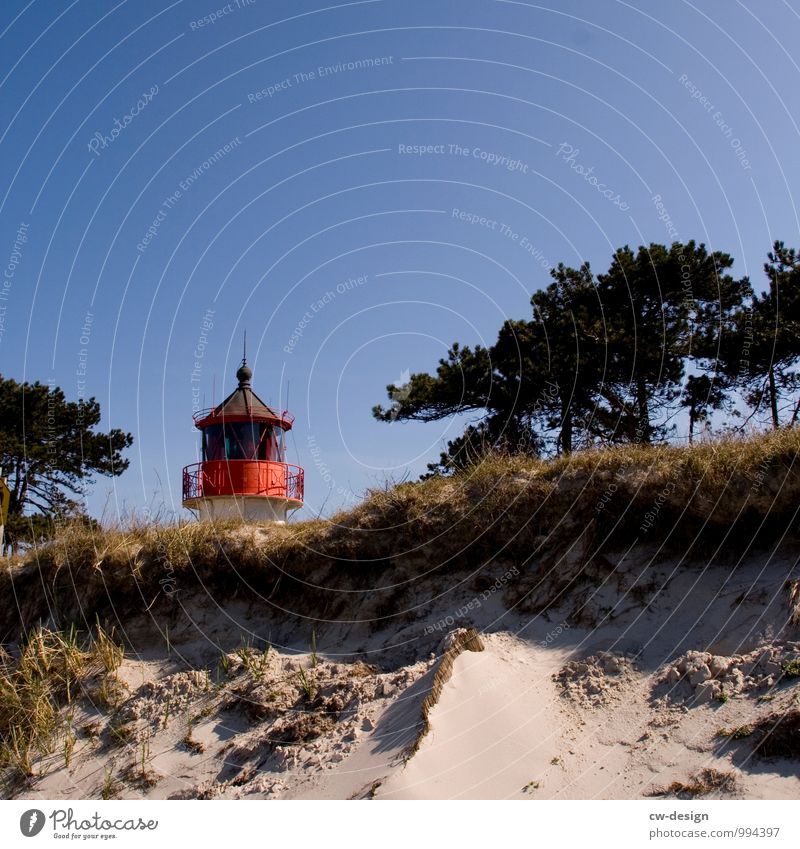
[377, 544, 800, 799]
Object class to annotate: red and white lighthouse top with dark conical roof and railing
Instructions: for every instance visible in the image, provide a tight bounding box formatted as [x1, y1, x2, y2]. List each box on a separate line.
[183, 359, 303, 524]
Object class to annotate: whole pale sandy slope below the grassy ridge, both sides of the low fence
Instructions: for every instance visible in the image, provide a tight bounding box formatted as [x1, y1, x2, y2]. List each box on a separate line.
[9, 552, 800, 799]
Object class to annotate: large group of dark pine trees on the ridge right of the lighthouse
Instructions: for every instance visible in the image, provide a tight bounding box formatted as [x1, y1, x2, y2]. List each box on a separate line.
[373, 241, 800, 472]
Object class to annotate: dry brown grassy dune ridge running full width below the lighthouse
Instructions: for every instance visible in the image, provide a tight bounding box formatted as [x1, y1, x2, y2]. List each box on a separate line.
[0, 429, 800, 642]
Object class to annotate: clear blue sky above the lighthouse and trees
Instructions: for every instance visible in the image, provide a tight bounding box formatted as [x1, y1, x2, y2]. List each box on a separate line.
[0, 0, 800, 518]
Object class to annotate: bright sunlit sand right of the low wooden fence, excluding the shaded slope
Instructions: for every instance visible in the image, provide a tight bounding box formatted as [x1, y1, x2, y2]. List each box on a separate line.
[376, 634, 800, 799]
